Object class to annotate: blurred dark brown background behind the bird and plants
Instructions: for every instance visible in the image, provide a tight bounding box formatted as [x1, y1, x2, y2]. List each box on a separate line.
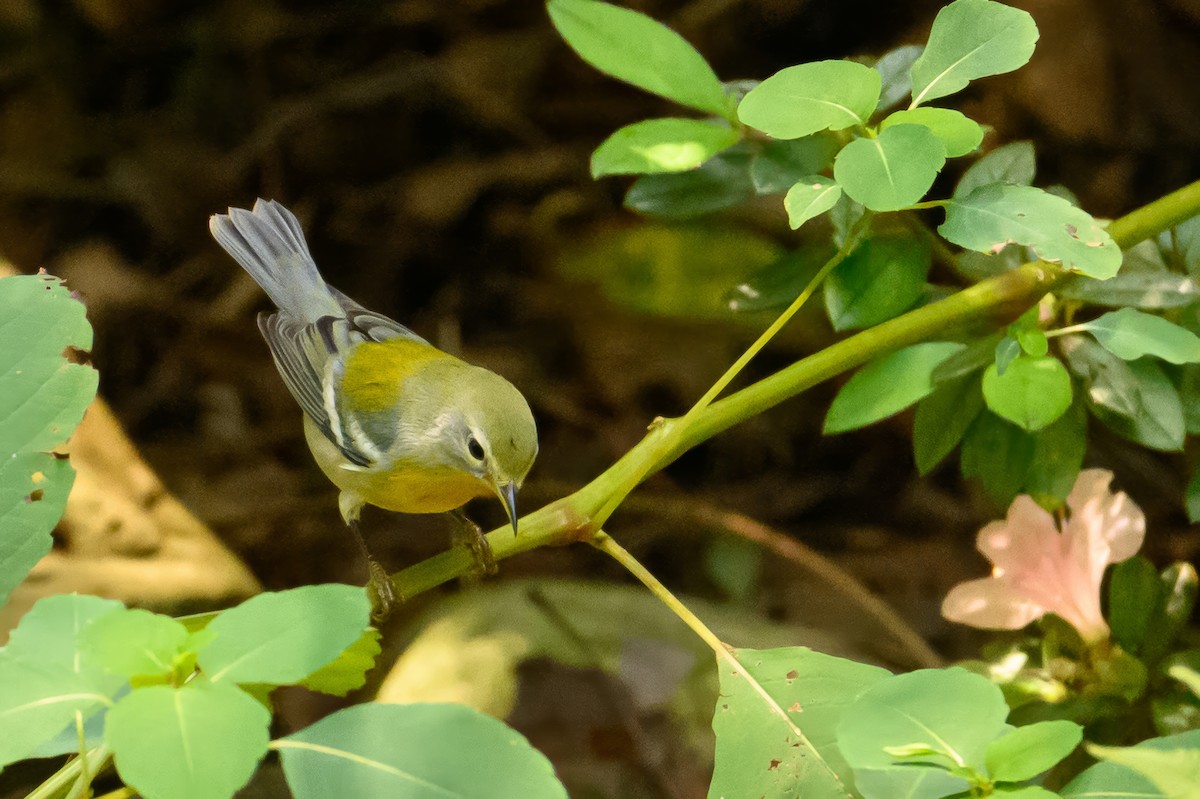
[0, 0, 1200, 795]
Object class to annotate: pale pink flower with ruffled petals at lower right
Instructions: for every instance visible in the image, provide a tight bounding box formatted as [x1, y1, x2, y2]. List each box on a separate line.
[942, 469, 1146, 641]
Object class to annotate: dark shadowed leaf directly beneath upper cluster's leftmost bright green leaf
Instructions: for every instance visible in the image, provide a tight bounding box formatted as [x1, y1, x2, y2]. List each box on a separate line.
[625, 145, 755, 220]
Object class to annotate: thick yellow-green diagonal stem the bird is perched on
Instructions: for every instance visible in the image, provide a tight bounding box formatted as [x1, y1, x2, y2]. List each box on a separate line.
[394, 181, 1200, 596]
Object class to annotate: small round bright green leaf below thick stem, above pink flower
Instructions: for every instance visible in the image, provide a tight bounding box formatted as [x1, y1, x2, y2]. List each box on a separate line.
[983, 355, 1072, 432]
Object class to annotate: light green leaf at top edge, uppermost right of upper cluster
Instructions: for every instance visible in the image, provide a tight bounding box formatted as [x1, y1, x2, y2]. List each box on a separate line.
[912, 0, 1038, 107]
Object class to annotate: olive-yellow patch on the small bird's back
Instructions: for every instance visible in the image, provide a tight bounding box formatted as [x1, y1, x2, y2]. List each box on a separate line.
[338, 338, 454, 414]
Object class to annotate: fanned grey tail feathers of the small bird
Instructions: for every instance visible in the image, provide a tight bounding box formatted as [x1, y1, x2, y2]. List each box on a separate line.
[209, 199, 344, 323]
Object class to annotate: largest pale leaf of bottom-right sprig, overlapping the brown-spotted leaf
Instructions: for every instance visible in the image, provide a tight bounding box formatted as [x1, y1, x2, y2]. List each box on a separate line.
[838, 667, 1008, 770]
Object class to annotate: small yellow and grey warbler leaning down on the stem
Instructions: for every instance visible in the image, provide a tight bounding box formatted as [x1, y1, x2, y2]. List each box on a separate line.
[209, 199, 538, 618]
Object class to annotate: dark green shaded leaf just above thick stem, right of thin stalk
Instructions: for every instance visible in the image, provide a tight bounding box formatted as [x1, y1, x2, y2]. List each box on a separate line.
[824, 235, 931, 330]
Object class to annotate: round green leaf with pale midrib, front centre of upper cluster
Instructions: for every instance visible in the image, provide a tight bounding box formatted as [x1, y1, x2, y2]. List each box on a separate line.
[833, 125, 946, 211]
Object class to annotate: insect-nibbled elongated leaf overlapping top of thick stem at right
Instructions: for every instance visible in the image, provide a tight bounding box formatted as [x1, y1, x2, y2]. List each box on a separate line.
[945, 183, 1121, 280]
